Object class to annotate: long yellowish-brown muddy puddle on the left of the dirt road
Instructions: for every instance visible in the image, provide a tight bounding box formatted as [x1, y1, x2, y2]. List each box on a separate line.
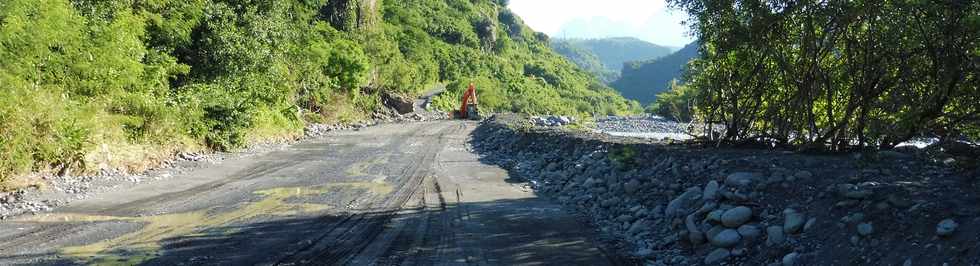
[24, 180, 392, 265]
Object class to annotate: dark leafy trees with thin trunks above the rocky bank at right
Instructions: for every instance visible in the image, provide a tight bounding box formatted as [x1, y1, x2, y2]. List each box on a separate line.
[669, 0, 980, 150]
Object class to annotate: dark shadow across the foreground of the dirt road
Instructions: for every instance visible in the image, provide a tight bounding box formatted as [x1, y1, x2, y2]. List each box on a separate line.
[0, 196, 613, 265]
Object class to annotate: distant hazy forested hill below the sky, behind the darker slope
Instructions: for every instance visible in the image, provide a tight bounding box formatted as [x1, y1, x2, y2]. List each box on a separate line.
[551, 37, 671, 82]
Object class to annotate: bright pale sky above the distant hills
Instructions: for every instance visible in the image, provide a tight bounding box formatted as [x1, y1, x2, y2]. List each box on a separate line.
[509, 0, 693, 47]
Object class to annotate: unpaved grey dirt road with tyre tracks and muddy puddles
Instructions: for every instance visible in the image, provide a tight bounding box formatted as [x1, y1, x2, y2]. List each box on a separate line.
[0, 121, 615, 265]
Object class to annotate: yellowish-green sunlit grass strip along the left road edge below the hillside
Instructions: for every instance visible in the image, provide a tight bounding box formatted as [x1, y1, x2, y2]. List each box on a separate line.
[0, 87, 386, 191]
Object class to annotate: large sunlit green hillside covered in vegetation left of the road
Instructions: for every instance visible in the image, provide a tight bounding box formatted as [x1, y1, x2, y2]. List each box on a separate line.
[0, 0, 638, 186]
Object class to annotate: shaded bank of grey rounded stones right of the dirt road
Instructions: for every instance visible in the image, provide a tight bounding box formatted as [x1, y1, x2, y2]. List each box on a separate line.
[474, 116, 980, 265]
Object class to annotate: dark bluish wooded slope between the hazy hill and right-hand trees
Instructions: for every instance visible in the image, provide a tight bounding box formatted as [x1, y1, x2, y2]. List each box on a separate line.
[609, 43, 698, 104]
